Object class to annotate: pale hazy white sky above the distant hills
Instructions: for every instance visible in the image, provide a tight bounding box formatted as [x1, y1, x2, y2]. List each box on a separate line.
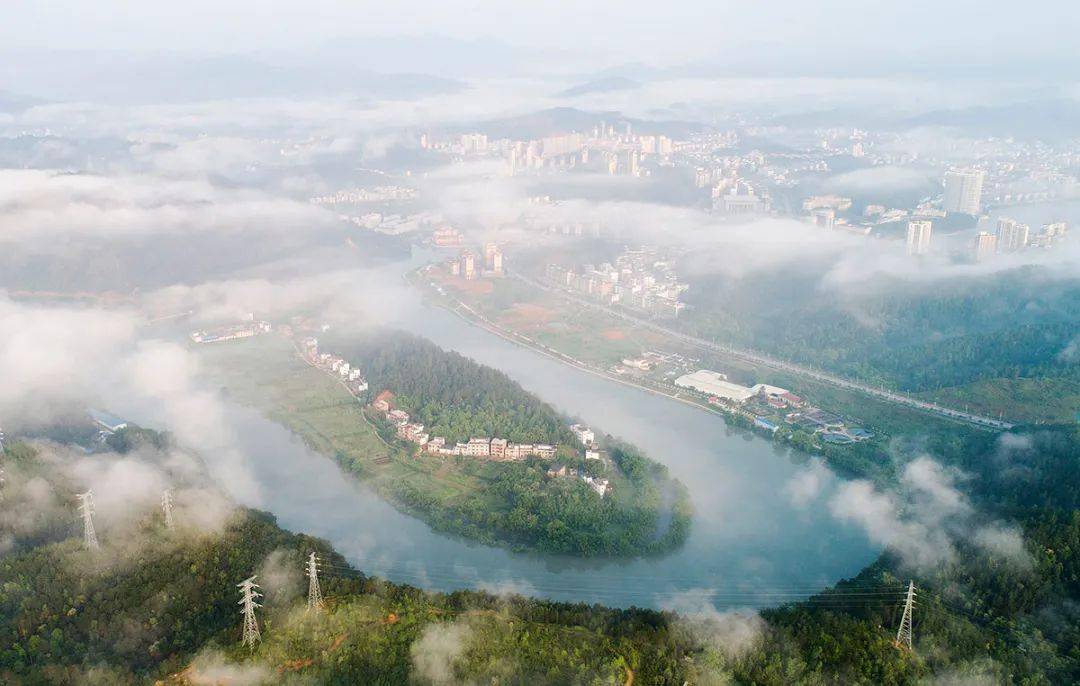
[0, 0, 1080, 67]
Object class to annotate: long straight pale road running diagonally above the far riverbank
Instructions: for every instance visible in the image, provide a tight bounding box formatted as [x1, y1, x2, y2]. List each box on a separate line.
[510, 272, 1014, 429]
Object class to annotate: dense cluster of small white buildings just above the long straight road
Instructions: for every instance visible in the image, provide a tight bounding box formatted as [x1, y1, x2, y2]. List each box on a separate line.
[544, 246, 690, 318]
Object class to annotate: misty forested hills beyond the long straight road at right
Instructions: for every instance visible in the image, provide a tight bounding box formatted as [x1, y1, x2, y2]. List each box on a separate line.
[683, 264, 1080, 399]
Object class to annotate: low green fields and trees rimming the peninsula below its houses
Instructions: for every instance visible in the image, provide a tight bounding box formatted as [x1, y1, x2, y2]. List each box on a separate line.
[199, 335, 691, 556]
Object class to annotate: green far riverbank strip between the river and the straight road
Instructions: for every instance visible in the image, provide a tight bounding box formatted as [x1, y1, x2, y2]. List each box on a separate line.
[404, 267, 967, 485]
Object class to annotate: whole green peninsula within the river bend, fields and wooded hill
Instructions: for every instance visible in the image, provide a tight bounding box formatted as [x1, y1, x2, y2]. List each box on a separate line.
[201, 332, 691, 556]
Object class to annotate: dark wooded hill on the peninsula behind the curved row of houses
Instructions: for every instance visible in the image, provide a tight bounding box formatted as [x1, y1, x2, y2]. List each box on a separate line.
[325, 331, 578, 445]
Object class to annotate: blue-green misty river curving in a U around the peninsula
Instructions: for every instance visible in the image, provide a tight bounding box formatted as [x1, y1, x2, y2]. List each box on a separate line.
[187, 254, 879, 607]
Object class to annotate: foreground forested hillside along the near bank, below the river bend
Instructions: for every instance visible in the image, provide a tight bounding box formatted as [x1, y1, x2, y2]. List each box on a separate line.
[0, 421, 1080, 686]
